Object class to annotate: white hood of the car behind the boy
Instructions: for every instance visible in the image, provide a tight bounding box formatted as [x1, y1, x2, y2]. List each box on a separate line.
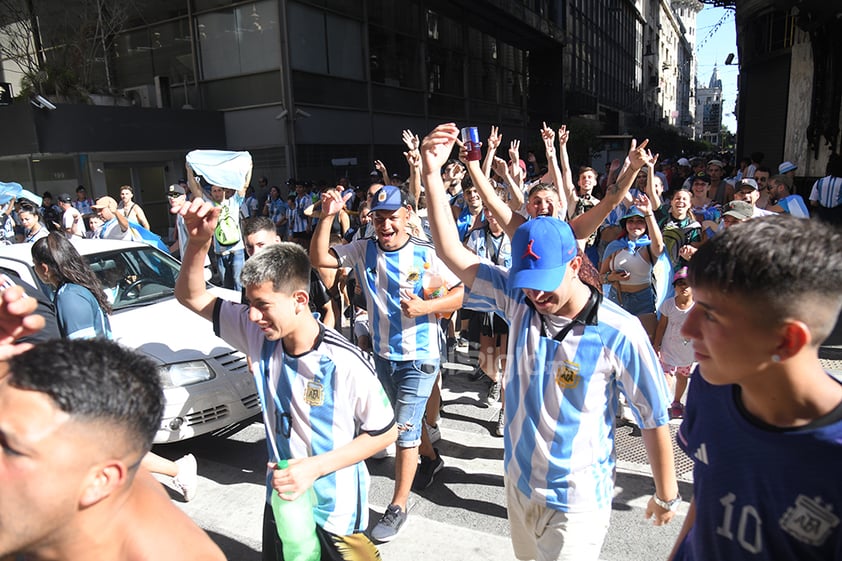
[110, 289, 239, 364]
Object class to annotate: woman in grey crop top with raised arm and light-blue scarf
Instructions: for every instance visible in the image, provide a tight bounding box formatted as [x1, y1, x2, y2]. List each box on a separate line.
[599, 195, 664, 339]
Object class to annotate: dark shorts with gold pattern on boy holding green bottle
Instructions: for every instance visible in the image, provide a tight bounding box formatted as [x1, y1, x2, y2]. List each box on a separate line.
[261, 504, 380, 561]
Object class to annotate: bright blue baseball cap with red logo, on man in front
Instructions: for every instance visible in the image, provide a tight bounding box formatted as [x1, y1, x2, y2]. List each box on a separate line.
[509, 216, 579, 292]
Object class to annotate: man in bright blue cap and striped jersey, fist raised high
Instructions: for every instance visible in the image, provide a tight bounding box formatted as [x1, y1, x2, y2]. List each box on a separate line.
[421, 124, 681, 561]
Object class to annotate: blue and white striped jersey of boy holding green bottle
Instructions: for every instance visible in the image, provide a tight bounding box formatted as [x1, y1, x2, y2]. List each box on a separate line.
[214, 299, 395, 536]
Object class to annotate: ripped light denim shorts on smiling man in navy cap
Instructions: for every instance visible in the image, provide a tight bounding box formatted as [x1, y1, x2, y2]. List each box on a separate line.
[374, 355, 440, 448]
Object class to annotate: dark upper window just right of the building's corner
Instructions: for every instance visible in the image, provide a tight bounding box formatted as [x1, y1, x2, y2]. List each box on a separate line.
[289, 3, 365, 80]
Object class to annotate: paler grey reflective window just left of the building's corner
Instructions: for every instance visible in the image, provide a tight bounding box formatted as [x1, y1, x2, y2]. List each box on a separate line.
[196, 0, 280, 80]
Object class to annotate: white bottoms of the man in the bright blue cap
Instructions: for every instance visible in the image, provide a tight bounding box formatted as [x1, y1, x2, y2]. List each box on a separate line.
[504, 477, 611, 561]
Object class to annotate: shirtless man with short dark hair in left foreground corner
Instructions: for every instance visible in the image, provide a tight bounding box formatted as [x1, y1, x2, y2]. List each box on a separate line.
[0, 312, 225, 561]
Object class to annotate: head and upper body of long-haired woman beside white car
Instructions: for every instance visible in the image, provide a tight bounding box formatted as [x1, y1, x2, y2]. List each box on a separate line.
[32, 232, 111, 339]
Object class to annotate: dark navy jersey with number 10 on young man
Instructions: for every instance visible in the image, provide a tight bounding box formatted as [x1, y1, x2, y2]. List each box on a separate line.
[675, 368, 842, 561]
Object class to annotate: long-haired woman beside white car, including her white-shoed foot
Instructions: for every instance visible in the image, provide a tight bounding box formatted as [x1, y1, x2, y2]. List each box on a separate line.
[32, 232, 198, 501]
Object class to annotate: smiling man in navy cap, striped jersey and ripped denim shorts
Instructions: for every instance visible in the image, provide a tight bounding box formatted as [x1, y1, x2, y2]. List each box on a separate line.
[310, 185, 462, 542]
